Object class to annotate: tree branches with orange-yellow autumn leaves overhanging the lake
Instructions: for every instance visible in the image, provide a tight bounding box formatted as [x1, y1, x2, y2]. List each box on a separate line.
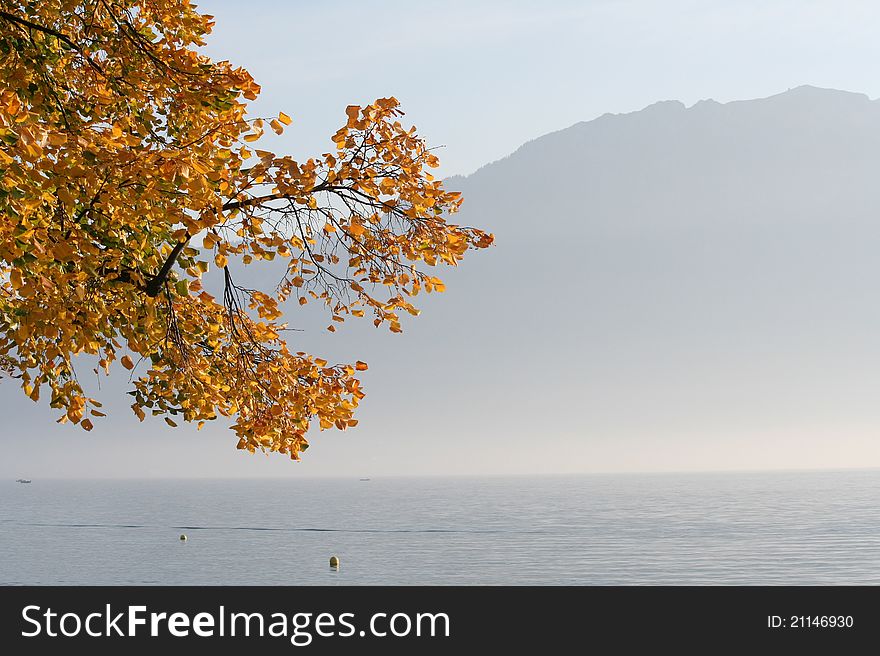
[0, 0, 492, 459]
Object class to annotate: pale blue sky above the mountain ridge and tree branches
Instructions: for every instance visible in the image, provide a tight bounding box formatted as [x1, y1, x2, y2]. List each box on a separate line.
[200, 0, 880, 174]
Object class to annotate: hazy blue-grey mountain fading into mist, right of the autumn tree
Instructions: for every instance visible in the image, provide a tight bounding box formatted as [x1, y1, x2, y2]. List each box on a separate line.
[367, 87, 880, 450]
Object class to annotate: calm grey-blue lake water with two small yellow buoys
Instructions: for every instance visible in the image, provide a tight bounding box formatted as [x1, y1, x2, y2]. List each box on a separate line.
[0, 471, 880, 585]
